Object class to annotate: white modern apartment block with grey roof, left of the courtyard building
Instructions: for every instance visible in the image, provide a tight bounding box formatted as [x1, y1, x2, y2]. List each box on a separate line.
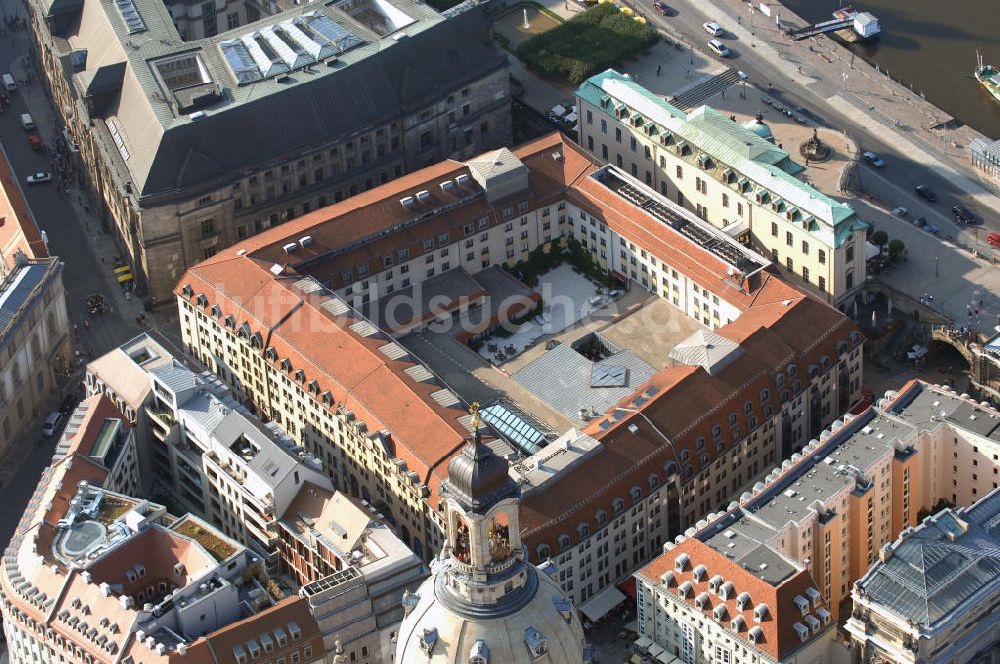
[146, 361, 330, 569]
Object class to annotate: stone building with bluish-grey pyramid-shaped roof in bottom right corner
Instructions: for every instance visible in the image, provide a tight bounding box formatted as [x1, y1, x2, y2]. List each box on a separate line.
[845, 490, 1000, 664]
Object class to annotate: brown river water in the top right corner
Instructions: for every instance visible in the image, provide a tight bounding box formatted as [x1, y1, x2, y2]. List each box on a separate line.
[781, 0, 1000, 138]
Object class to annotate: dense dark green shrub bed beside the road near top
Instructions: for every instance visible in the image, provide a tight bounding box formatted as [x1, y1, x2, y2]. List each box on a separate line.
[517, 4, 659, 84]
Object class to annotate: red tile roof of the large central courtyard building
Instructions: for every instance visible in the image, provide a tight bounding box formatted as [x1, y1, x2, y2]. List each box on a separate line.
[176, 134, 854, 542]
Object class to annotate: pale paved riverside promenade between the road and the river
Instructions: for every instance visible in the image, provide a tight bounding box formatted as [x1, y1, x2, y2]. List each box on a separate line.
[684, 0, 1000, 209]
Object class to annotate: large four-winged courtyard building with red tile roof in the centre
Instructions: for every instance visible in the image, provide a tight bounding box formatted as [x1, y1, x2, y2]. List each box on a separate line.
[176, 135, 863, 603]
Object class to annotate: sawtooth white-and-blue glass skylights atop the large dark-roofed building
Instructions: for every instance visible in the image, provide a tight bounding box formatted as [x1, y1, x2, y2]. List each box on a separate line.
[219, 12, 364, 85]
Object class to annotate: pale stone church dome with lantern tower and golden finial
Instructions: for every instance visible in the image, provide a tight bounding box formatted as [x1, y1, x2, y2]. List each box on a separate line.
[395, 404, 587, 664]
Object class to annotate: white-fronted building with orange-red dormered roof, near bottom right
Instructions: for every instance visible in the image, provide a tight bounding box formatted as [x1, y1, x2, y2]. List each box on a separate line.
[635, 538, 836, 664]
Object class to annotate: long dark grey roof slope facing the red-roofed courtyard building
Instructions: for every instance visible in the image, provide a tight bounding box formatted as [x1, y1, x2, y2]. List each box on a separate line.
[130, 10, 505, 197]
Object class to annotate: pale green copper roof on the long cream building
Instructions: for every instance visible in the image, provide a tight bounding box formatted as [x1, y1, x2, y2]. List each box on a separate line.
[576, 69, 868, 246]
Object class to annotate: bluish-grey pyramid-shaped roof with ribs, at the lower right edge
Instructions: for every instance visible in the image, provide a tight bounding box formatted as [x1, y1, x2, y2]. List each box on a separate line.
[858, 490, 1000, 628]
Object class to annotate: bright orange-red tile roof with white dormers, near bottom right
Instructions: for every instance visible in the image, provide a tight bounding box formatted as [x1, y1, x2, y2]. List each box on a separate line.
[636, 537, 826, 661]
